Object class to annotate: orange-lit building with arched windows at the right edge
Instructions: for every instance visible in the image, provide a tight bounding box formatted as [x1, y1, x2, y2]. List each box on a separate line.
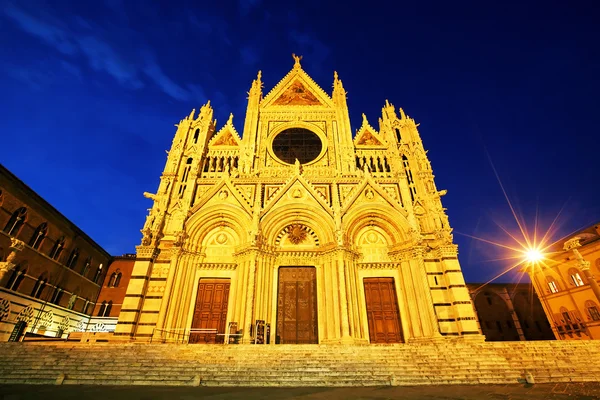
[526, 223, 600, 340]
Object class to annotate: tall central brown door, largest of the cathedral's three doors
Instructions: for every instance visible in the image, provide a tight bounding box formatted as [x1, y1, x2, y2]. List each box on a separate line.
[276, 267, 319, 344]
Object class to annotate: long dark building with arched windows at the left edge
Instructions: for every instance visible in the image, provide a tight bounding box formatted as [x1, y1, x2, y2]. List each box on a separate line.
[0, 165, 111, 341]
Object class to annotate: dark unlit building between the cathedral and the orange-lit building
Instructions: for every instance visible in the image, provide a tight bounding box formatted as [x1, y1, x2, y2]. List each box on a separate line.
[467, 283, 554, 342]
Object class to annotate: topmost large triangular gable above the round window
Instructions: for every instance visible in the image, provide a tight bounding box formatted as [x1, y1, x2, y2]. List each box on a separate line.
[260, 66, 333, 108]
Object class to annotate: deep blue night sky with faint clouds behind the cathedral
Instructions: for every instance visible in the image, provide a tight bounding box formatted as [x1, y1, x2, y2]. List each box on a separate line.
[0, 0, 600, 282]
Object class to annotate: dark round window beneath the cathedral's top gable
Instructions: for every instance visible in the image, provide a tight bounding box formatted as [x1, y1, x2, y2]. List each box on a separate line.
[273, 128, 323, 164]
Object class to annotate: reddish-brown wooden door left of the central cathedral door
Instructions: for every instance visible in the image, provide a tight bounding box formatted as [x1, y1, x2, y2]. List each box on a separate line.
[189, 279, 230, 343]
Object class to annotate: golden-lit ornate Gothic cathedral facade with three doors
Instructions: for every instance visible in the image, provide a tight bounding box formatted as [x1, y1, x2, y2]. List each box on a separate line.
[115, 56, 480, 344]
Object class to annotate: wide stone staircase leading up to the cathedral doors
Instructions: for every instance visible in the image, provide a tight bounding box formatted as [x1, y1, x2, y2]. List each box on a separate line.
[0, 339, 600, 387]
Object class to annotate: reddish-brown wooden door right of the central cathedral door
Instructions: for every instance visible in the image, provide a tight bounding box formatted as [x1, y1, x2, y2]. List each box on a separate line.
[364, 278, 402, 343]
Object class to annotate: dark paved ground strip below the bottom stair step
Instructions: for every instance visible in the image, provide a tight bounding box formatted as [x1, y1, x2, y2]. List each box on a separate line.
[0, 383, 600, 400]
